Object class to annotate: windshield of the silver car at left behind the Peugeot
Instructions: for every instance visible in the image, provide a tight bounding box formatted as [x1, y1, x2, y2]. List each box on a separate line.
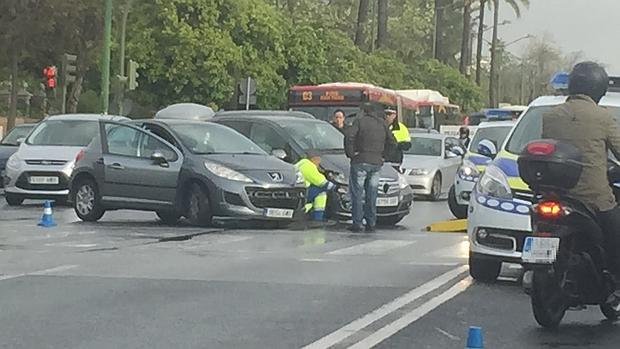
[26, 119, 99, 147]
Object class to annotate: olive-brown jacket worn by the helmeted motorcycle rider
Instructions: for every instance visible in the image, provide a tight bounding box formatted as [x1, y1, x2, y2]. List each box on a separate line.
[542, 95, 620, 211]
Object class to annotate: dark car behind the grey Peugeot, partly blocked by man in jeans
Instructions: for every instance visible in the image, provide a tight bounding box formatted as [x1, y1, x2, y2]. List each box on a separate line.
[213, 111, 413, 225]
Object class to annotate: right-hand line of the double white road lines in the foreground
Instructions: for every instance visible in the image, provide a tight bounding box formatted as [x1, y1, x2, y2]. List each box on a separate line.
[349, 277, 472, 349]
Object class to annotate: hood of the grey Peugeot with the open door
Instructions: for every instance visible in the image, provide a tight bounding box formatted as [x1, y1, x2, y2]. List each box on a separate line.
[200, 154, 297, 185]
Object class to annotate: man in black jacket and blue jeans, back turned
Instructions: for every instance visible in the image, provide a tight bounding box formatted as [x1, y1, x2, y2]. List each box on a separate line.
[344, 103, 396, 232]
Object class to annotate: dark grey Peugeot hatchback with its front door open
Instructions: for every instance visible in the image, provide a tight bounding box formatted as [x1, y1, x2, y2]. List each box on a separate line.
[70, 119, 305, 226]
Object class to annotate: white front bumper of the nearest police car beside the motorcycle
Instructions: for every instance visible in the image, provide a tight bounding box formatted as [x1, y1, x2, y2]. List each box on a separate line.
[467, 190, 532, 263]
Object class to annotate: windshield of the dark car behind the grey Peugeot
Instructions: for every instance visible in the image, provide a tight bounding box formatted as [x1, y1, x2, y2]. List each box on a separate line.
[278, 120, 344, 150]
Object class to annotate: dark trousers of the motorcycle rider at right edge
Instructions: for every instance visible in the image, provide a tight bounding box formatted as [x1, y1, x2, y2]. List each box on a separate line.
[598, 206, 620, 293]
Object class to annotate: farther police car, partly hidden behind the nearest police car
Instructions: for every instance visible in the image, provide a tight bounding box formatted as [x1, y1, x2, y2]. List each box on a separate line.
[448, 121, 516, 219]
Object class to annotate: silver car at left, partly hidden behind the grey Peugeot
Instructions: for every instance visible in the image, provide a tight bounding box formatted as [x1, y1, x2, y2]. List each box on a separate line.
[4, 114, 128, 206]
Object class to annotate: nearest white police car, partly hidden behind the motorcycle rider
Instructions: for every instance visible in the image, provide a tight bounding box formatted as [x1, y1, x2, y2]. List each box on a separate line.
[467, 74, 620, 281]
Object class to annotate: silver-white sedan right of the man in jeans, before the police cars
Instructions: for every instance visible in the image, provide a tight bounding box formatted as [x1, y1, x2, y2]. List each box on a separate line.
[401, 133, 465, 201]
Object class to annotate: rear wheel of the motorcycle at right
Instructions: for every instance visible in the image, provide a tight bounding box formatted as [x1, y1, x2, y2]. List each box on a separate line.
[531, 271, 568, 329]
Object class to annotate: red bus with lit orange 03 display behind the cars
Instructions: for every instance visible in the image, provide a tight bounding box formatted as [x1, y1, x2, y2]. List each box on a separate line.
[288, 82, 418, 126]
